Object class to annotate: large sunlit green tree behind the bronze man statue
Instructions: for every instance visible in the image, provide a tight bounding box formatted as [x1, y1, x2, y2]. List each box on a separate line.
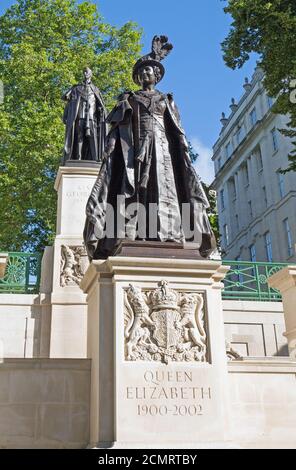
[0, 0, 142, 251]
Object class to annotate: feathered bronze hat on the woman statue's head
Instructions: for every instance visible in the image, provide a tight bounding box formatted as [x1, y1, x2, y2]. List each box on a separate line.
[133, 36, 173, 85]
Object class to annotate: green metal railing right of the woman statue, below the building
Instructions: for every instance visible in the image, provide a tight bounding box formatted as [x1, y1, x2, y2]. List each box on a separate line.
[222, 260, 287, 302]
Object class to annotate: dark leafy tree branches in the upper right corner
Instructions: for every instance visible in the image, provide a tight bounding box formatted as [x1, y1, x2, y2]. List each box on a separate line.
[222, 0, 296, 171]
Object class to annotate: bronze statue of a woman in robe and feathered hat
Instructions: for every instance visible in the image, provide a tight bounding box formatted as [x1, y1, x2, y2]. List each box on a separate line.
[84, 36, 216, 259]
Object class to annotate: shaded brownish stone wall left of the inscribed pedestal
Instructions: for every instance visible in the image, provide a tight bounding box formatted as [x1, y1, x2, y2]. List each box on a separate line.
[0, 359, 90, 449]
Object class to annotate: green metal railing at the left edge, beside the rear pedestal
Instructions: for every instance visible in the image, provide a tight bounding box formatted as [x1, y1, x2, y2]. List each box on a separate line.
[0, 252, 42, 294]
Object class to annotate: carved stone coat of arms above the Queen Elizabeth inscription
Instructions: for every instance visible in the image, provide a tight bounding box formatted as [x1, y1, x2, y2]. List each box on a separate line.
[124, 281, 207, 364]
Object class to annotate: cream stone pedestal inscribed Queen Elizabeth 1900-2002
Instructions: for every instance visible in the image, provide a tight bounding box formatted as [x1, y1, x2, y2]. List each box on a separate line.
[81, 256, 229, 448]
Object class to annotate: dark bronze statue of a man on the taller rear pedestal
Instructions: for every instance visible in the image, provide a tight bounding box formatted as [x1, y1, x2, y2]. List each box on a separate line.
[63, 67, 106, 163]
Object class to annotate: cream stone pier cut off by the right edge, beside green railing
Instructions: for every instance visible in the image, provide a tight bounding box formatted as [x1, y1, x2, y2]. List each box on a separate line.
[268, 266, 296, 360]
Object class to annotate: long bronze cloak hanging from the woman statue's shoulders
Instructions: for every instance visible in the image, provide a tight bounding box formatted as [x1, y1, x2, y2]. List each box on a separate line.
[84, 92, 216, 259]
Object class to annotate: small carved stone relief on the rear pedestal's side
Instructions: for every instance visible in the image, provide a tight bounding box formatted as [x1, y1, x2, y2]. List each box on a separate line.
[60, 245, 88, 287]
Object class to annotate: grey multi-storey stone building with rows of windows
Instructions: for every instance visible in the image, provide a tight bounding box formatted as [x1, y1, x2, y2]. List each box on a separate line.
[212, 67, 296, 262]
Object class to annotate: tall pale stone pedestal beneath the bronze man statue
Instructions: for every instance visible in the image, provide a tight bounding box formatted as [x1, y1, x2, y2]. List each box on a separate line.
[41, 165, 99, 358]
